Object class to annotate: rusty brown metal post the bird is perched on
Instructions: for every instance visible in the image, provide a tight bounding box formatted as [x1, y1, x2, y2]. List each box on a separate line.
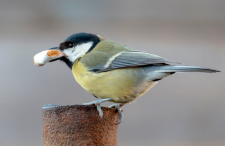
[42, 105, 119, 146]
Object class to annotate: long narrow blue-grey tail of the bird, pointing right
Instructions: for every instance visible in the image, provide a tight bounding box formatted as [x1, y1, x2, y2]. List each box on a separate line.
[157, 66, 220, 73]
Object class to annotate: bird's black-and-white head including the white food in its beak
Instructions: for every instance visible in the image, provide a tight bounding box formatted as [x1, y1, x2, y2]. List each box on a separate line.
[34, 33, 101, 68]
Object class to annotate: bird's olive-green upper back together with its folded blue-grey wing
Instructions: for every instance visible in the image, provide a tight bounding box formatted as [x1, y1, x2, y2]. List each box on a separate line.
[81, 41, 176, 72]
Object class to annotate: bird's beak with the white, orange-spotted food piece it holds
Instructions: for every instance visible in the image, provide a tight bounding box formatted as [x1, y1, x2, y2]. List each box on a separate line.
[34, 47, 65, 66]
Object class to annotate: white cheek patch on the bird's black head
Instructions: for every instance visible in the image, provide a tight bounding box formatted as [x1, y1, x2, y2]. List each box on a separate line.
[64, 42, 93, 62]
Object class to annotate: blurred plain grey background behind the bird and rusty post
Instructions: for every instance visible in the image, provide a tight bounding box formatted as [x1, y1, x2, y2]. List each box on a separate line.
[0, 0, 225, 146]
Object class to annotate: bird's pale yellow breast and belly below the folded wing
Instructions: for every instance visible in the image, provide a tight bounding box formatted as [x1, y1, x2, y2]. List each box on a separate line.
[72, 61, 148, 102]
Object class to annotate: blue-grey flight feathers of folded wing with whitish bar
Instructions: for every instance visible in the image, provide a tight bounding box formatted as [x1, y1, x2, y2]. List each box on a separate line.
[99, 50, 176, 72]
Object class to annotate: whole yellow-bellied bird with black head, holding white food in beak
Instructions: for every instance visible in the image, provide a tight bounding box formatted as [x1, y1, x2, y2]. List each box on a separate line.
[34, 32, 220, 124]
